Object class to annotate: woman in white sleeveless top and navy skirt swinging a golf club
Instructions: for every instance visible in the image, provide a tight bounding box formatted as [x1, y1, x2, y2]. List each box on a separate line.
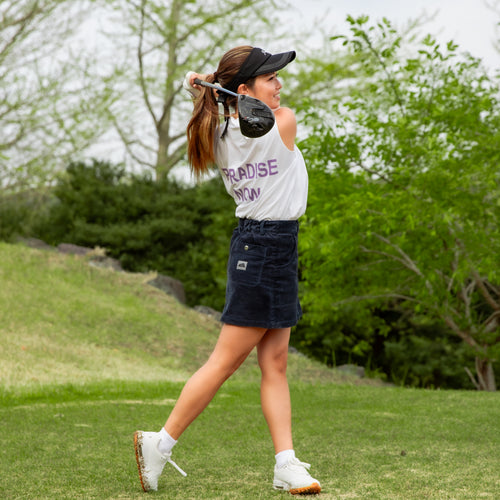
[134, 46, 321, 494]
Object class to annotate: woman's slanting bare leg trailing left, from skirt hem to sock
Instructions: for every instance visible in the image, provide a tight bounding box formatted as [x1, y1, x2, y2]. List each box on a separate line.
[165, 324, 266, 439]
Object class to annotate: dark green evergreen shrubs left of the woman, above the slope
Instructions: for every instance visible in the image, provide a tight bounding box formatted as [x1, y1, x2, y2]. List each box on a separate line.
[37, 160, 235, 309]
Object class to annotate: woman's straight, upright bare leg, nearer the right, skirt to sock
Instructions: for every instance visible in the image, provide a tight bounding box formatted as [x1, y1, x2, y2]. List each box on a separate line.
[257, 328, 293, 453]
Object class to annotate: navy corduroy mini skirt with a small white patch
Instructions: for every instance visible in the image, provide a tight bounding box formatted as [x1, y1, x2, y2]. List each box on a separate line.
[221, 219, 302, 328]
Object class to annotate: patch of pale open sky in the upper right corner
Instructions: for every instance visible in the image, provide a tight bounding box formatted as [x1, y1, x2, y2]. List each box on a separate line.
[289, 0, 500, 69]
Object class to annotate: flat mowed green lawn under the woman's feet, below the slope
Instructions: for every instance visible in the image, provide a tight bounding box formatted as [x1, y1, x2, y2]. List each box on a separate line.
[0, 381, 500, 500]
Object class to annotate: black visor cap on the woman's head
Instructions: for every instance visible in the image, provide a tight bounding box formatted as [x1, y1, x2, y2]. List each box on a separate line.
[226, 47, 296, 92]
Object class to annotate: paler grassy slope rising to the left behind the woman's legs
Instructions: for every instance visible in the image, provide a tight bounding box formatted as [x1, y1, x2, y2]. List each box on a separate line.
[0, 243, 362, 392]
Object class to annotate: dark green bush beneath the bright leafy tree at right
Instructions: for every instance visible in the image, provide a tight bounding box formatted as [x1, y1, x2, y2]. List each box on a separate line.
[292, 304, 474, 389]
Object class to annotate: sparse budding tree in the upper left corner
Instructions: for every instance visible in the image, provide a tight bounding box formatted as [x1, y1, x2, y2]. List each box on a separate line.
[0, 0, 116, 190]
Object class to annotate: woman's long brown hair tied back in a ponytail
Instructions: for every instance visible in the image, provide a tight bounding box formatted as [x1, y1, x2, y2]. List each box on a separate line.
[187, 45, 253, 178]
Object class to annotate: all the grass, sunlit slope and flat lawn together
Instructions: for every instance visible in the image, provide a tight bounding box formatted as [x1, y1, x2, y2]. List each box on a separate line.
[0, 240, 500, 500]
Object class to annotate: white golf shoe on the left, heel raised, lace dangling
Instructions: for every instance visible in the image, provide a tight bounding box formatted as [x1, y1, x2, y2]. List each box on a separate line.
[134, 431, 187, 491]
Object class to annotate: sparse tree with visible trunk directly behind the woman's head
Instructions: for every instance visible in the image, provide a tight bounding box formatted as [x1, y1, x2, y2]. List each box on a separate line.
[98, 0, 283, 178]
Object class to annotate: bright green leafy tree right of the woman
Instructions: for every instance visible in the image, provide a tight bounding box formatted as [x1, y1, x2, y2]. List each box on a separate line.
[302, 17, 500, 390]
